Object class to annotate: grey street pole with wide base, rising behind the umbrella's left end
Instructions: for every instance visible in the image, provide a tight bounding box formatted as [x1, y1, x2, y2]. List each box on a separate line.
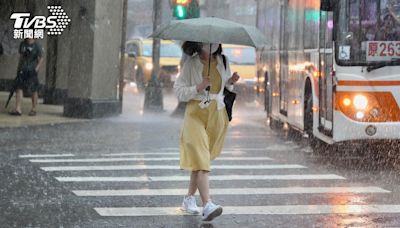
[144, 0, 164, 112]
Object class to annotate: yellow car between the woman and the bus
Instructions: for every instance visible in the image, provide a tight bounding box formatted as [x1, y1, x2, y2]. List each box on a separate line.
[222, 44, 258, 102]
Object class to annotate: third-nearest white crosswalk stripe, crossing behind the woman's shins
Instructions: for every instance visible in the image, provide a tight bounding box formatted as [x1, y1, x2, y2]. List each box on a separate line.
[56, 174, 345, 182]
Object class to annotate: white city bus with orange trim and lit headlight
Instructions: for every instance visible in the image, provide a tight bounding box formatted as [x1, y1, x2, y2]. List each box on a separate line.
[257, 0, 400, 144]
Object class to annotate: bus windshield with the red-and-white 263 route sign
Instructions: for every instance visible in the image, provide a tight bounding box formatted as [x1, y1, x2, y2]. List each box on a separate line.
[335, 0, 400, 66]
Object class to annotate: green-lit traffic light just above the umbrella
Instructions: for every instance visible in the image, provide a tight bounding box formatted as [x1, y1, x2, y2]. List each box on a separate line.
[172, 0, 200, 20]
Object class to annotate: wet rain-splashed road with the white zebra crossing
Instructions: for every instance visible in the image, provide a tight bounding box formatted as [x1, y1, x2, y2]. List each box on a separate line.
[0, 90, 400, 227]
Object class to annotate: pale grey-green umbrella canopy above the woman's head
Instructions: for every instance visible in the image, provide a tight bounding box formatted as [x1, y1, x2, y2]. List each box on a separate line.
[150, 17, 268, 48]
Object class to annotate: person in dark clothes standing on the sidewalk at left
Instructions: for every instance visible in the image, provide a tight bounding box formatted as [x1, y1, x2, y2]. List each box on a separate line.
[10, 38, 43, 116]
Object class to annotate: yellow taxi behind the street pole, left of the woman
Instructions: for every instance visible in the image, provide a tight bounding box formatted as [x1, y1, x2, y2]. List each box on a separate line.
[125, 38, 182, 90]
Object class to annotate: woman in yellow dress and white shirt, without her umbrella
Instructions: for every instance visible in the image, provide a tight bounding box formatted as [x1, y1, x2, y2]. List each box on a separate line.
[174, 41, 239, 221]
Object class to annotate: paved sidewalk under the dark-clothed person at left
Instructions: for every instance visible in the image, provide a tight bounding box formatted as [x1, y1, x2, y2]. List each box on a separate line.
[0, 92, 83, 128]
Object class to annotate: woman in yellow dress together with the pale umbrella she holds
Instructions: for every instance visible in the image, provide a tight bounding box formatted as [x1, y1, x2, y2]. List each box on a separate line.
[151, 17, 269, 221]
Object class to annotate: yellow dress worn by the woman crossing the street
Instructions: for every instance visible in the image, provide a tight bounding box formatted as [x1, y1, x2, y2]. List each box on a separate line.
[180, 59, 229, 171]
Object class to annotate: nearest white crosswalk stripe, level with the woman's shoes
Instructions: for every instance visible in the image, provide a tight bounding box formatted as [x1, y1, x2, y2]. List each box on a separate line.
[94, 204, 400, 217]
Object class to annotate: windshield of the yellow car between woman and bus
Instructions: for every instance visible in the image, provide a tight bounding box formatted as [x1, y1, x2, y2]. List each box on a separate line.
[224, 47, 256, 65]
